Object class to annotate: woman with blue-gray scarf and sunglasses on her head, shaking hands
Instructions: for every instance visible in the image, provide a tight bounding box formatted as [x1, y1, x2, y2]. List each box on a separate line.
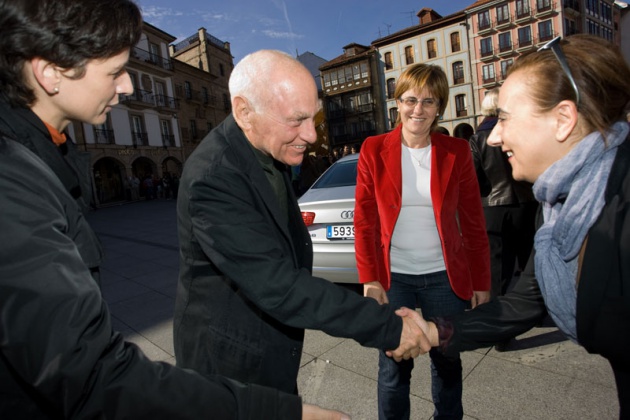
[400, 35, 630, 419]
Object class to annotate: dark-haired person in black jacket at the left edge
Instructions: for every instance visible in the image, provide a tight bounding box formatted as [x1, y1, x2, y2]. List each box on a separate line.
[0, 0, 348, 420]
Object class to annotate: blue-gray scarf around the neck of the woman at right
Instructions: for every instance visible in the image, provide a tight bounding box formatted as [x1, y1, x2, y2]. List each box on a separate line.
[534, 122, 630, 342]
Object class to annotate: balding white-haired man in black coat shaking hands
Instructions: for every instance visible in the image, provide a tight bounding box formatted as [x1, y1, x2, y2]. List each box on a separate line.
[173, 50, 430, 393]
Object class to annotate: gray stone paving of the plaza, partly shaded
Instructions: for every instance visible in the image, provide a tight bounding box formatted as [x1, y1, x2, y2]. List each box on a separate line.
[88, 200, 618, 420]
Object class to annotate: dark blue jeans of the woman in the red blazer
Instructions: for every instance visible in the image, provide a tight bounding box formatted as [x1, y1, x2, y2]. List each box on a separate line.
[378, 271, 469, 420]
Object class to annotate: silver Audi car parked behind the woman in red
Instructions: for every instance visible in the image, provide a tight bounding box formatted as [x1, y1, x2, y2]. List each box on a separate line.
[298, 153, 359, 284]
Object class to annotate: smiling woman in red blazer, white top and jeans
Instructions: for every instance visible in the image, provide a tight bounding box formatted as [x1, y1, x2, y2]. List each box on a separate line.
[354, 64, 490, 419]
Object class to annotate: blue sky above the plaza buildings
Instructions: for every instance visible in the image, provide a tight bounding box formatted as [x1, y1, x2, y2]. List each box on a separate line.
[136, 0, 475, 64]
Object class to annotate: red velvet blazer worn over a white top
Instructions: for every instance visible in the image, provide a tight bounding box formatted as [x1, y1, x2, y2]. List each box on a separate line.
[354, 125, 490, 300]
